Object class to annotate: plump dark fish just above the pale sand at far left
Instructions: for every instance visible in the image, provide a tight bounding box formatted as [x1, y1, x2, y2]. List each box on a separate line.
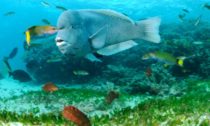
[9, 70, 32, 82]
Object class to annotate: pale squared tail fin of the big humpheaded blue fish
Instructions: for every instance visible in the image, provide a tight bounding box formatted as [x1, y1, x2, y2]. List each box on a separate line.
[137, 17, 161, 43]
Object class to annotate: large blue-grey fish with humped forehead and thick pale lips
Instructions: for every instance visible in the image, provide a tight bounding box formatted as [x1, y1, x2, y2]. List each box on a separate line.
[56, 10, 160, 61]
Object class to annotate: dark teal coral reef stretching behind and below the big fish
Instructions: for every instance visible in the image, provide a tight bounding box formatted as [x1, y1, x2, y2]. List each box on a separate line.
[20, 20, 210, 89]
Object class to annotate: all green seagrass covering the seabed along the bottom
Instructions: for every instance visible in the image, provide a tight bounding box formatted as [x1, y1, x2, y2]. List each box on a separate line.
[0, 80, 210, 126]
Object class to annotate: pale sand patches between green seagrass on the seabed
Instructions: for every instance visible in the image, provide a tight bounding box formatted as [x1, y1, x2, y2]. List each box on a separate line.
[0, 78, 151, 116]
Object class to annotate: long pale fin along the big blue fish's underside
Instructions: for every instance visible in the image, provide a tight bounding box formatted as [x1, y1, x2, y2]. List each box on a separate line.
[97, 40, 138, 56]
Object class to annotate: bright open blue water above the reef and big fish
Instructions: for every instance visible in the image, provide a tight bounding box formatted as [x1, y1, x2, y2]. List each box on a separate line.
[0, 0, 210, 68]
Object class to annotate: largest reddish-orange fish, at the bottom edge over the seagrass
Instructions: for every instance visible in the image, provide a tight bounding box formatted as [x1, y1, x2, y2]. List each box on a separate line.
[62, 106, 91, 126]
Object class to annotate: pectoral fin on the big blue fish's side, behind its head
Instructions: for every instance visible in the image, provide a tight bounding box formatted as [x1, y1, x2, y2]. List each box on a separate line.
[89, 25, 107, 49]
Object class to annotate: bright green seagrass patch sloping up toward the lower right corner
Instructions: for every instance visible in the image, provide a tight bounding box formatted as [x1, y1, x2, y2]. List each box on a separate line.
[92, 81, 210, 126]
